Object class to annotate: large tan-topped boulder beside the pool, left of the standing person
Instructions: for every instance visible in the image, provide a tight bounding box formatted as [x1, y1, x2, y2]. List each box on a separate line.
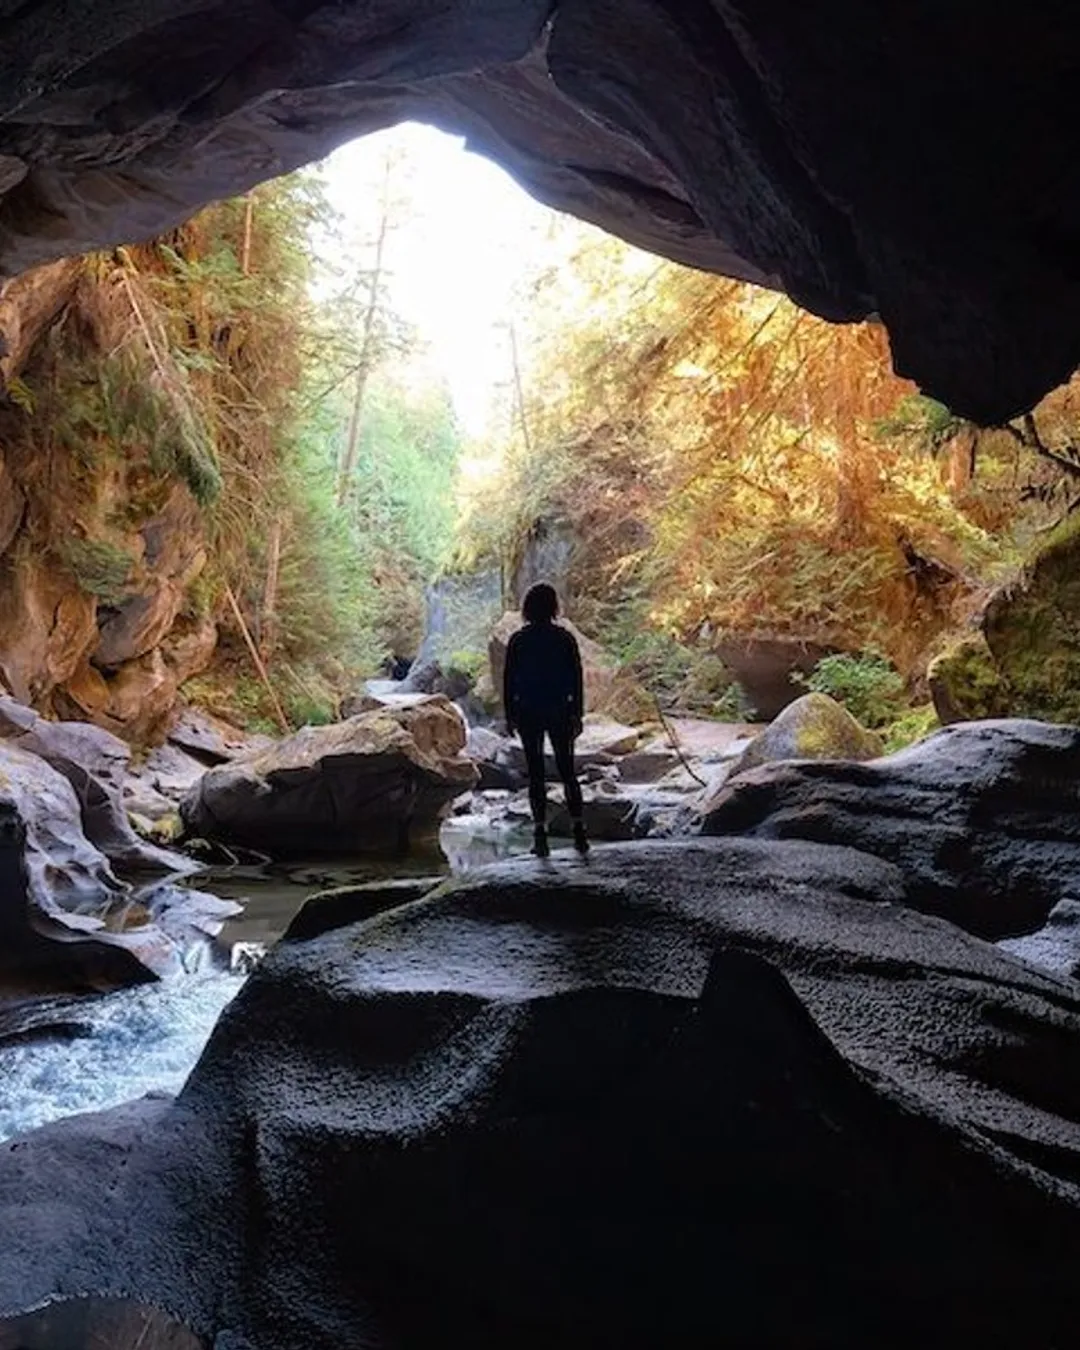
[181, 695, 478, 856]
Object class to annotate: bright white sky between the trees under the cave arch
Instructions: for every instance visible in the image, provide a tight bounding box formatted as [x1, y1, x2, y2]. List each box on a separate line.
[324, 123, 552, 436]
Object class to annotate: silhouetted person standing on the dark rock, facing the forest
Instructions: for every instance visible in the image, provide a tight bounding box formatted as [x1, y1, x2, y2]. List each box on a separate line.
[502, 582, 589, 857]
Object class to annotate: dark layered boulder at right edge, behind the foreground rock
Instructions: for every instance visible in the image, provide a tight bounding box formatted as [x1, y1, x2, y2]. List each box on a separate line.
[702, 721, 1080, 937]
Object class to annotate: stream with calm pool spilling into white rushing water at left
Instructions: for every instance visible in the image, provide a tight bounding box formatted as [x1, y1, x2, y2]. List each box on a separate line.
[0, 819, 531, 1141]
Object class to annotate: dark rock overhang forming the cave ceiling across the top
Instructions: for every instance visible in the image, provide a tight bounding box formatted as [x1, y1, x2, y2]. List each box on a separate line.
[0, 0, 1080, 423]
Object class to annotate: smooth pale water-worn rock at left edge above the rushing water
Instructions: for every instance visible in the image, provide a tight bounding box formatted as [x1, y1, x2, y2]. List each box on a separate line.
[0, 740, 239, 990]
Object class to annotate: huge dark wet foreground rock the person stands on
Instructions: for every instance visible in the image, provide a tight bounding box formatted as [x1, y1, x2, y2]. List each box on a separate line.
[0, 840, 1080, 1350]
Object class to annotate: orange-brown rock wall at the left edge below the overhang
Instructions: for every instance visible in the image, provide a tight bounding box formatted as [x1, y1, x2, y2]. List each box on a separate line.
[0, 261, 217, 743]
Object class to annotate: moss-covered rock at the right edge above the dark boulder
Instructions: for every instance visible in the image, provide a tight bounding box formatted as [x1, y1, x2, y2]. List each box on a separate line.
[929, 518, 1080, 722]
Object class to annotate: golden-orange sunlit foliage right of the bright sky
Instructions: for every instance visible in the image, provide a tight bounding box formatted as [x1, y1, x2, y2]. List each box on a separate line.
[464, 239, 1063, 674]
